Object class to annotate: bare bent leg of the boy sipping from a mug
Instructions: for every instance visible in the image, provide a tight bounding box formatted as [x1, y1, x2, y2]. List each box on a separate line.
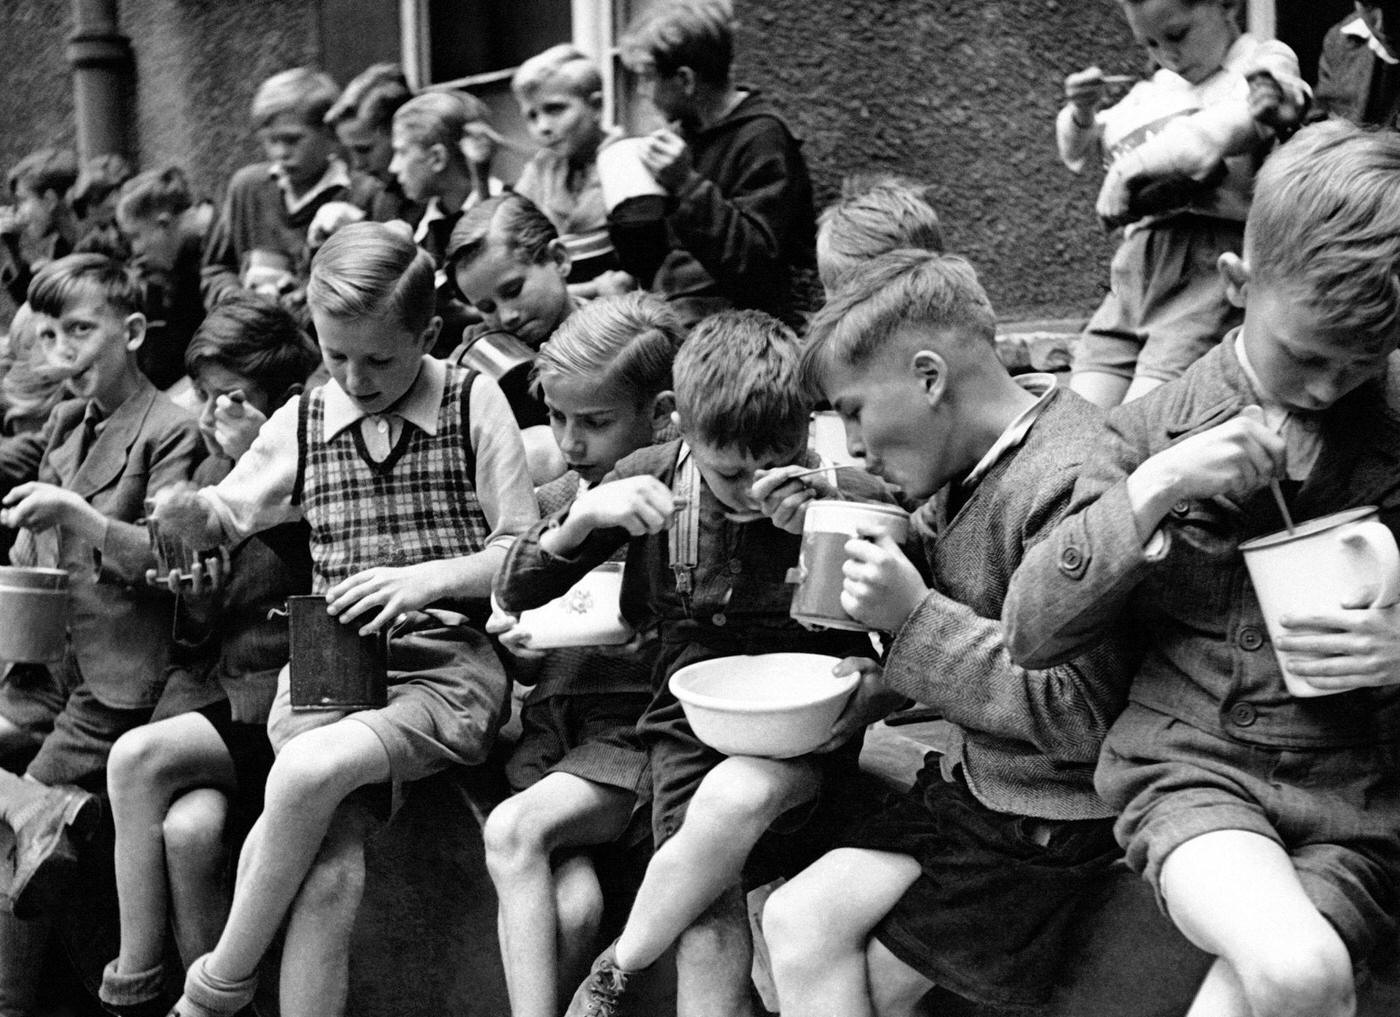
[763, 848, 920, 1017]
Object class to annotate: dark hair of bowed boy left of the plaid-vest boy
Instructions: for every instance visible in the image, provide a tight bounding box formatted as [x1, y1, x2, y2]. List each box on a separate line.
[185, 290, 321, 405]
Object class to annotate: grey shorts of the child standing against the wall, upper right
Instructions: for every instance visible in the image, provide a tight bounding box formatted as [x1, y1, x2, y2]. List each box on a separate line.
[1074, 216, 1245, 381]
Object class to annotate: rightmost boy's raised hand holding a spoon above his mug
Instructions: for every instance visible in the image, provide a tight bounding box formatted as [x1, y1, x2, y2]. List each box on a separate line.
[1128, 406, 1284, 539]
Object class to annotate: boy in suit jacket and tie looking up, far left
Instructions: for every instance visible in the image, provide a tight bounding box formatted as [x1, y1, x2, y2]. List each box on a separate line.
[0, 255, 203, 997]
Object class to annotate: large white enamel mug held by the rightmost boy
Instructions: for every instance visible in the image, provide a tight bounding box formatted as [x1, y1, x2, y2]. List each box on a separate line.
[1239, 506, 1400, 696]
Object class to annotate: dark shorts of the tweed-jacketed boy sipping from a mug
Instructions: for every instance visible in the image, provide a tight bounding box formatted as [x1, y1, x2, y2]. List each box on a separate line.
[843, 762, 1120, 1006]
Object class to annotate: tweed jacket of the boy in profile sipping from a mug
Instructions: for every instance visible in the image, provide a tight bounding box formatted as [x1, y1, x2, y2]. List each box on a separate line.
[885, 389, 1137, 819]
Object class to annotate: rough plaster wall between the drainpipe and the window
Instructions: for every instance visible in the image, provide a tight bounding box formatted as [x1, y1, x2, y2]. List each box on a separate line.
[120, 0, 318, 207]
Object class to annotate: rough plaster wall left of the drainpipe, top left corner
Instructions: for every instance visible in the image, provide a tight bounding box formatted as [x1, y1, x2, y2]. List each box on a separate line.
[0, 0, 77, 180]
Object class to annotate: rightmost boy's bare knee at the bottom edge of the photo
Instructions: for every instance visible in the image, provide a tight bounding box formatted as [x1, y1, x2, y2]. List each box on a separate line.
[1238, 934, 1357, 1017]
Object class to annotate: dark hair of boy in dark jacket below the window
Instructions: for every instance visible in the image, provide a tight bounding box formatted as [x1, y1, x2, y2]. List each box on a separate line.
[617, 0, 734, 84]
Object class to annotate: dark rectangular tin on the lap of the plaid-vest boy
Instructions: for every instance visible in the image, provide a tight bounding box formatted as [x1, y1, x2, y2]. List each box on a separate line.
[287, 594, 388, 713]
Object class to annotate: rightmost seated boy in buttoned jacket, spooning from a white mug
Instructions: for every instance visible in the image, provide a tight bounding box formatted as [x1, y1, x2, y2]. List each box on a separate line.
[1005, 122, 1400, 1017]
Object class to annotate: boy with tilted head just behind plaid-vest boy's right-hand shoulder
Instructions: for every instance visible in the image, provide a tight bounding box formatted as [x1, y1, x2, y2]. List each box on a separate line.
[447, 193, 578, 483]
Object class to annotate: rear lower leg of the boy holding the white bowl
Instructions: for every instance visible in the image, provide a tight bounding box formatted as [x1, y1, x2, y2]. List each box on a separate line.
[676, 884, 753, 1017]
